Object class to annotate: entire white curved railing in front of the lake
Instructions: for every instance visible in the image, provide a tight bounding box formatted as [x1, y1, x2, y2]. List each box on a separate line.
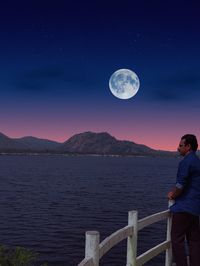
[78, 203, 172, 266]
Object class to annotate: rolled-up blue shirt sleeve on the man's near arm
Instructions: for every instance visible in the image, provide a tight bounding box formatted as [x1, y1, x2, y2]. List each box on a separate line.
[176, 160, 190, 189]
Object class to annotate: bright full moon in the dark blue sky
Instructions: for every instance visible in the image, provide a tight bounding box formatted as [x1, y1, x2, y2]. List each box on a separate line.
[109, 69, 140, 100]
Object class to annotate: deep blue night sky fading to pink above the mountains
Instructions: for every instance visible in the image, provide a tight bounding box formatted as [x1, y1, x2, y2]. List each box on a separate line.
[0, 0, 200, 150]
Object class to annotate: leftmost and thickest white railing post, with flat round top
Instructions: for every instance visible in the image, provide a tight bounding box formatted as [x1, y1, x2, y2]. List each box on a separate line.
[85, 231, 100, 266]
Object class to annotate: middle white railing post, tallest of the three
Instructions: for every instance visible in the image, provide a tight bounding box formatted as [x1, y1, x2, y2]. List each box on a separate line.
[126, 211, 138, 266]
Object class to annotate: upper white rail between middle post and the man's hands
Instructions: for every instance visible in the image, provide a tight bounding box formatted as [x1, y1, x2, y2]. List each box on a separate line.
[138, 210, 170, 231]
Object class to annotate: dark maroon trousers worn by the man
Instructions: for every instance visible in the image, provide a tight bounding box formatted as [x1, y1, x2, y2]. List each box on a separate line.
[171, 212, 200, 266]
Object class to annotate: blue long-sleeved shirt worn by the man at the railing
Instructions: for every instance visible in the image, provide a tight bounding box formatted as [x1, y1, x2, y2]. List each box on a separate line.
[170, 152, 200, 215]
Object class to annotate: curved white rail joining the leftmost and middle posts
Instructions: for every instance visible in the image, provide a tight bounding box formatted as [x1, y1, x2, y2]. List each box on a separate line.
[99, 225, 133, 258]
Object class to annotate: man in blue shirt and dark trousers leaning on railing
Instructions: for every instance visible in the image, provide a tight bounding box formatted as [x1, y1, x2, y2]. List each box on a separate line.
[168, 134, 200, 266]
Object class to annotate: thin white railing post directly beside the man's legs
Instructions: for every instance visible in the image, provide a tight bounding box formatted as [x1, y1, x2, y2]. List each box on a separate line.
[165, 200, 174, 266]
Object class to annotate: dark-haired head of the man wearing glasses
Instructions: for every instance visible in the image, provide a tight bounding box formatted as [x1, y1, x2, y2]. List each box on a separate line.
[178, 134, 198, 156]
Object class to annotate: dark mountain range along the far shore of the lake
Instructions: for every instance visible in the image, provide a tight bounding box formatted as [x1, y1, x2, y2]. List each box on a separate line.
[0, 132, 174, 156]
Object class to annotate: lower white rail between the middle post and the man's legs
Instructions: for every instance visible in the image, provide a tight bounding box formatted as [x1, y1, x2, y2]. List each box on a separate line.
[136, 241, 170, 266]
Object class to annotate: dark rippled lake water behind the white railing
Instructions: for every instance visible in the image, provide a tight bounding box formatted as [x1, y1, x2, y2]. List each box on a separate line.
[0, 155, 180, 266]
